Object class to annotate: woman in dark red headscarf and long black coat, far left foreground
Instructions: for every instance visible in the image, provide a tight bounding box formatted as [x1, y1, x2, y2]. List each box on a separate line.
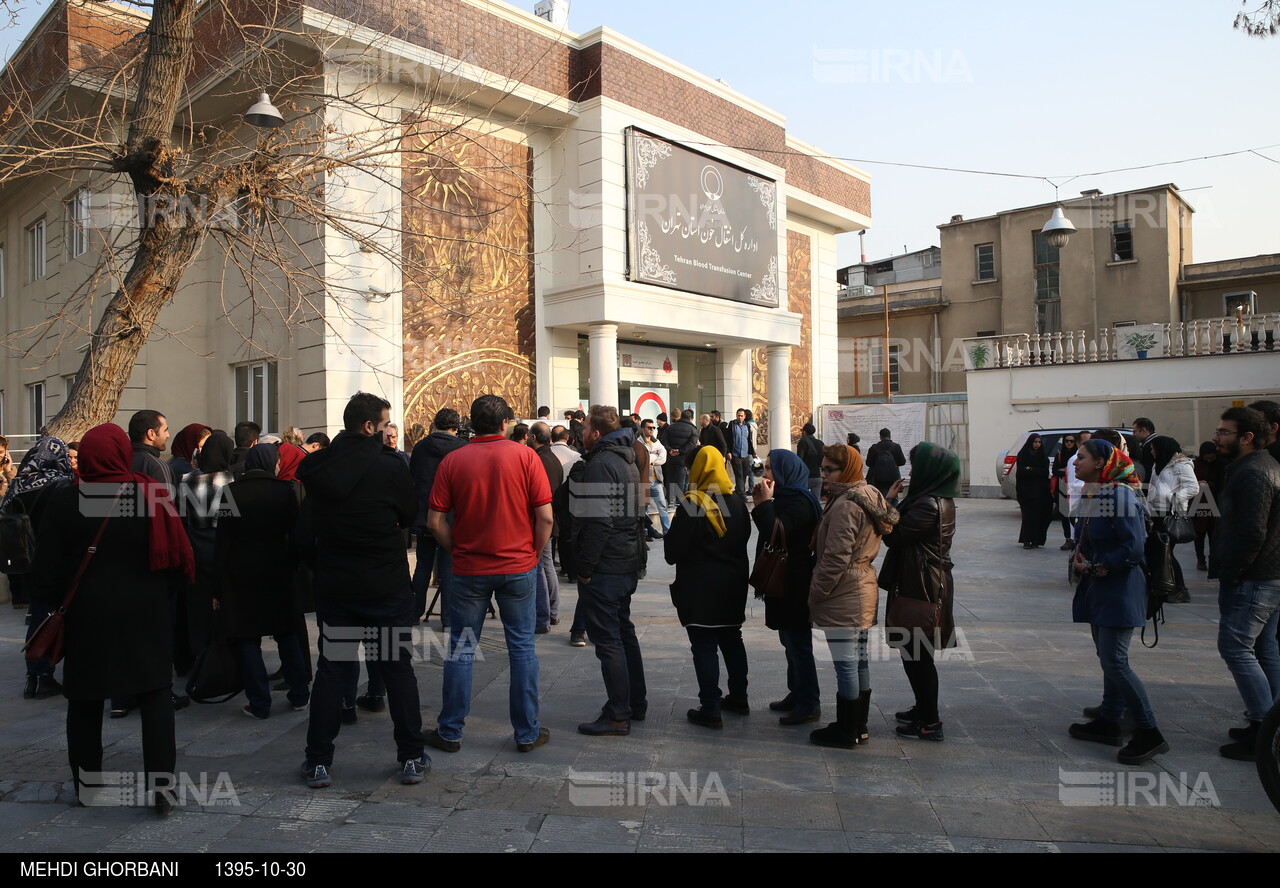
[37, 424, 195, 815]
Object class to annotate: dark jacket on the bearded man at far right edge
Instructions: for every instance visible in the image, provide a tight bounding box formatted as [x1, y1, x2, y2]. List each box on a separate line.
[1208, 450, 1280, 586]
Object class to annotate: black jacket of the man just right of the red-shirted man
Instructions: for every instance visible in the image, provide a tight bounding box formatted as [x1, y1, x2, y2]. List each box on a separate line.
[568, 429, 644, 580]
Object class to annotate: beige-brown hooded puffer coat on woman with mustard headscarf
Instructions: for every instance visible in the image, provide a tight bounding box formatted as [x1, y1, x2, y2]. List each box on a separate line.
[809, 481, 897, 630]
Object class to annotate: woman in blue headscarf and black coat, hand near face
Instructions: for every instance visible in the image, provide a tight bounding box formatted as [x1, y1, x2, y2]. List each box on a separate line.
[751, 449, 822, 724]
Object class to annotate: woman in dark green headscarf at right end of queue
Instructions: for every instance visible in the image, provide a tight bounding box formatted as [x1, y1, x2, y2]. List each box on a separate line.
[879, 441, 960, 741]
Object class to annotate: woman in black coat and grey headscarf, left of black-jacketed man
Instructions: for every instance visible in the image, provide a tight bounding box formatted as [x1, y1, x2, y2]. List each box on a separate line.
[215, 444, 311, 719]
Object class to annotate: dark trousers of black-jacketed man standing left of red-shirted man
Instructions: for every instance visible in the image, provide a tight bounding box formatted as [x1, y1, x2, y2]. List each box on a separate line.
[306, 601, 426, 768]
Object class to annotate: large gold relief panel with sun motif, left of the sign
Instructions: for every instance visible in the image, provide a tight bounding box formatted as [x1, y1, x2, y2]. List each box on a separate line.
[402, 128, 535, 427]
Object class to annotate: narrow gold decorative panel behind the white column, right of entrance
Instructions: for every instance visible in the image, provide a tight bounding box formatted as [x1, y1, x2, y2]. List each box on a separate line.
[751, 232, 813, 447]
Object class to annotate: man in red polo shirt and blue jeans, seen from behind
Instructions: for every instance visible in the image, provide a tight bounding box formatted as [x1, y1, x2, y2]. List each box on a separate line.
[426, 394, 552, 752]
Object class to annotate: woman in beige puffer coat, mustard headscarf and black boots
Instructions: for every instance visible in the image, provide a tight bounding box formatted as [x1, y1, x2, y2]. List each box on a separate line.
[809, 444, 897, 750]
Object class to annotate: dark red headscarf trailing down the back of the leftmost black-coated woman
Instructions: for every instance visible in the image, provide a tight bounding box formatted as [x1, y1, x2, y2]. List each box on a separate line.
[79, 422, 196, 582]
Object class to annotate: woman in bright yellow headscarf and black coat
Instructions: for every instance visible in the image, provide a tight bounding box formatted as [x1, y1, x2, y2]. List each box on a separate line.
[663, 447, 751, 728]
